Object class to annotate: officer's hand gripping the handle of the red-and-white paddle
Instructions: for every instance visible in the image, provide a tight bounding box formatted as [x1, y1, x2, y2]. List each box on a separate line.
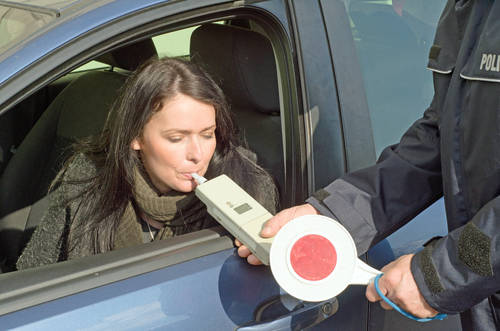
[366, 254, 438, 318]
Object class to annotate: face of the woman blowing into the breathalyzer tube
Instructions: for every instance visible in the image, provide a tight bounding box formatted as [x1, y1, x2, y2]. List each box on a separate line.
[131, 94, 216, 193]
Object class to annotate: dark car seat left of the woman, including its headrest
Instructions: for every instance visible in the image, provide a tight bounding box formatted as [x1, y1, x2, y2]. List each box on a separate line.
[0, 39, 156, 271]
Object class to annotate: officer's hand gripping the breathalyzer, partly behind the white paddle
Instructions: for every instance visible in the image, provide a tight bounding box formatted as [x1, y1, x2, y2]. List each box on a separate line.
[234, 203, 319, 265]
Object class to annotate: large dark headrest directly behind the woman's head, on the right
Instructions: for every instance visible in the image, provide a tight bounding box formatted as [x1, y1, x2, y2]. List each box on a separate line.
[190, 24, 279, 114]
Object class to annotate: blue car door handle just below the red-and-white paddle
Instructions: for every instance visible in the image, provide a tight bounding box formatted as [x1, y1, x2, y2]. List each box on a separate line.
[236, 296, 339, 331]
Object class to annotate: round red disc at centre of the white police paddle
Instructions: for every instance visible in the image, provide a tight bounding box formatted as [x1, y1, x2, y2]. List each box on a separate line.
[290, 234, 337, 281]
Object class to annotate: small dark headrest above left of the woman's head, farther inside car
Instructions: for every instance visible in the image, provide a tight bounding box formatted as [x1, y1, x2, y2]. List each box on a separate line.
[96, 39, 158, 71]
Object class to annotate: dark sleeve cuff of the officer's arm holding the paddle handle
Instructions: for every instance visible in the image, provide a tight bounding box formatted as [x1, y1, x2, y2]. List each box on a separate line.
[411, 196, 500, 314]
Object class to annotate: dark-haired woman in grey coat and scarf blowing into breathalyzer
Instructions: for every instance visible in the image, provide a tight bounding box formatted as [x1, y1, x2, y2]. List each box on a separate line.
[17, 58, 277, 269]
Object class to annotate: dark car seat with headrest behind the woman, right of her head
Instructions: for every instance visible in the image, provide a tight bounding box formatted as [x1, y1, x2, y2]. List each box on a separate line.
[190, 24, 284, 200]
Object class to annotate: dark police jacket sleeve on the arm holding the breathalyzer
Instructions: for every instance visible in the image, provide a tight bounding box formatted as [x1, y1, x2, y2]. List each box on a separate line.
[307, 97, 442, 254]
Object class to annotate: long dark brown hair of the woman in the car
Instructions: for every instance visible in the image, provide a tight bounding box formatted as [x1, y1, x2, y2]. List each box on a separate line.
[59, 58, 277, 254]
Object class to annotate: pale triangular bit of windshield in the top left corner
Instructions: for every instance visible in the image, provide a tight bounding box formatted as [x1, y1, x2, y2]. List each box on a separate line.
[0, 5, 56, 55]
